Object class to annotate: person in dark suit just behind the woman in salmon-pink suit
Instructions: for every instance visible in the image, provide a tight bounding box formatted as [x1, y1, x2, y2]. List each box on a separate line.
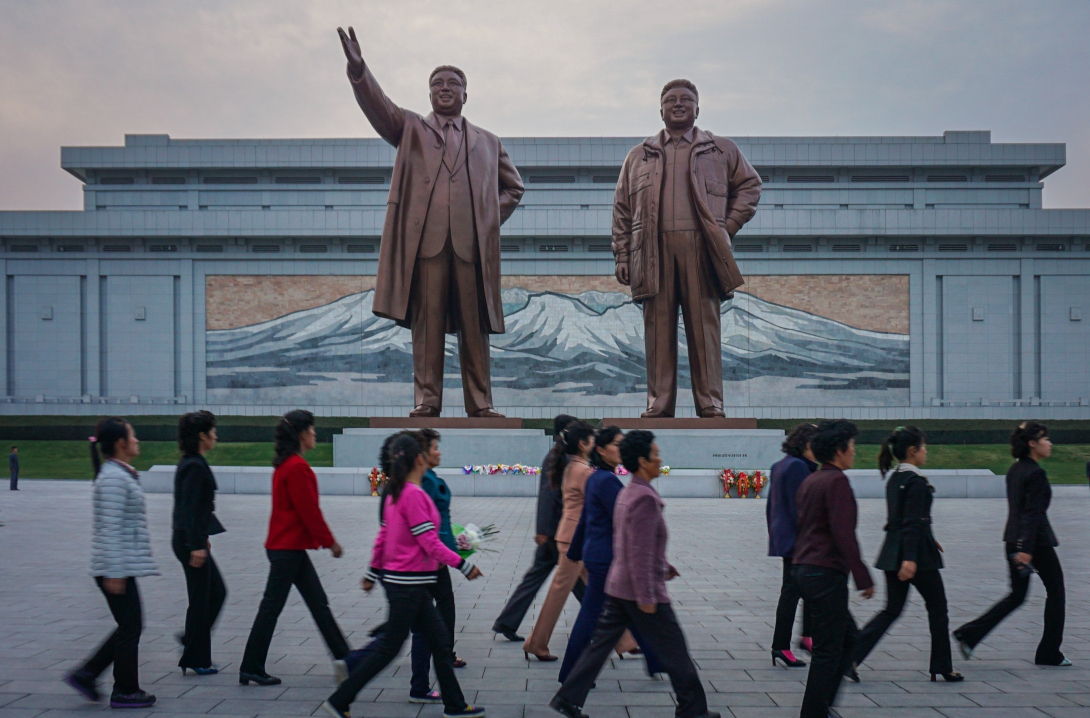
[492, 414, 583, 642]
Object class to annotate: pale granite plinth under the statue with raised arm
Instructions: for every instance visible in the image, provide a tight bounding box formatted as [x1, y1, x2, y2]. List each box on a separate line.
[334, 429, 553, 471]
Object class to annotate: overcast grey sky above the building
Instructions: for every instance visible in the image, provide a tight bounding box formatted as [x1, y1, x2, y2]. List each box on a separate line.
[0, 0, 1090, 209]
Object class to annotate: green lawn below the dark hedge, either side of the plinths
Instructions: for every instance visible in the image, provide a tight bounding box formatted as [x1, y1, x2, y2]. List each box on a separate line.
[10, 441, 1090, 484]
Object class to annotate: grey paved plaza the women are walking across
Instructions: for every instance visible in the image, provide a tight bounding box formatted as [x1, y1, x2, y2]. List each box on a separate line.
[0, 480, 1090, 718]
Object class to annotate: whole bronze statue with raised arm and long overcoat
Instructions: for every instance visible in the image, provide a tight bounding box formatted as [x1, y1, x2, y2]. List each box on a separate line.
[337, 27, 524, 417]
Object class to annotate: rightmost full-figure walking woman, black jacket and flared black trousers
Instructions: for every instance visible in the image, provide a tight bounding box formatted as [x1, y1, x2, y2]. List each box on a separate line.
[954, 422, 1071, 666]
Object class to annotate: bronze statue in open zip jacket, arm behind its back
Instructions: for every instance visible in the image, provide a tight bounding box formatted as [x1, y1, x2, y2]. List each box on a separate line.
[613, 80, 761, 418]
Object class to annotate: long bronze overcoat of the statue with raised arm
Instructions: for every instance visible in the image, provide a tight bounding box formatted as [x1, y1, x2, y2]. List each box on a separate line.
[349, 66, 525, 333]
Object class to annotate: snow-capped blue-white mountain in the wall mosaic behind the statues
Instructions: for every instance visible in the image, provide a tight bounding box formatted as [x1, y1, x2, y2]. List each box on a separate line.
[206, 288, 909, 407]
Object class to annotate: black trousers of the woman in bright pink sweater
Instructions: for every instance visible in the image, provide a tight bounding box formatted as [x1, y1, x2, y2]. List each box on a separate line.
[329, 583, 467, 711]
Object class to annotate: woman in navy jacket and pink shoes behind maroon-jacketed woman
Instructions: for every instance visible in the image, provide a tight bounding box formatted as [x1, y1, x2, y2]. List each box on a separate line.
[765, 424, 818, 668]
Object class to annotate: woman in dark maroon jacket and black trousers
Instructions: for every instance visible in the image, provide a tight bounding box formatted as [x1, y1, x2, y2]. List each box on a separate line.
[792, 419, 874, 718]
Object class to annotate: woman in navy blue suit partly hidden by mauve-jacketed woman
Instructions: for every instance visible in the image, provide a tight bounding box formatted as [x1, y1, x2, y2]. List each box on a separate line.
[559, 426, 664, 683]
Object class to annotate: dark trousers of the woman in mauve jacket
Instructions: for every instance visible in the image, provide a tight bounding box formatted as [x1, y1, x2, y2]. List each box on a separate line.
[556, 596, 707, 718]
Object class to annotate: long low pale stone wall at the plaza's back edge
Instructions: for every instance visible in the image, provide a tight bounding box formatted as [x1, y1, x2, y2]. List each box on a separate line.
[141, 465, 1006, 499]
